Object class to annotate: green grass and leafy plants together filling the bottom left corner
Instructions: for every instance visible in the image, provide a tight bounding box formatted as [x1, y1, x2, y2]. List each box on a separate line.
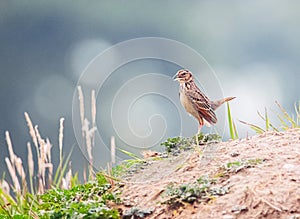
[0, 173, 120, 219]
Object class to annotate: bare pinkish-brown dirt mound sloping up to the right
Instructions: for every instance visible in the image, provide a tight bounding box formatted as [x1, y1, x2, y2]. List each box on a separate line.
[120, 129, 300, 219]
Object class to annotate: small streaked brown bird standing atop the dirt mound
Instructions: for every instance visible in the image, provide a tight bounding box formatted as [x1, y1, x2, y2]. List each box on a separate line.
[175, 69, 235, 133]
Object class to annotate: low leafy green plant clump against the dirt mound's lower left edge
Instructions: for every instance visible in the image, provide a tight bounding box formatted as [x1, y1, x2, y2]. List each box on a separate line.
[38, 174, 119, 219]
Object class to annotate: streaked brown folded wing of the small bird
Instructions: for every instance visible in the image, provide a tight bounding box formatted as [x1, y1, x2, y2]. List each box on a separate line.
[187, 88, 217, 124]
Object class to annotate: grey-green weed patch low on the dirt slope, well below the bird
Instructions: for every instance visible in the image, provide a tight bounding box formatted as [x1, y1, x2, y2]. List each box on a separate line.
[163, 176, 229, 205]
